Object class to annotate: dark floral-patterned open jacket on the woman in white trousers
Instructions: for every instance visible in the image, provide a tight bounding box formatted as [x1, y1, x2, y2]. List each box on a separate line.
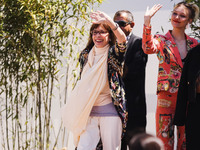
[79, 42, 127, 135]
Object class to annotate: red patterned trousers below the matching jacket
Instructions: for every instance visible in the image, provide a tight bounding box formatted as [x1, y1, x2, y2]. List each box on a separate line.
[156, 91, 186, 150]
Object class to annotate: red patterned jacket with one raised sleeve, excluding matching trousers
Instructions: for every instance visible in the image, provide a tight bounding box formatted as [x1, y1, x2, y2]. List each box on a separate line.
[142, 26, 198, 93]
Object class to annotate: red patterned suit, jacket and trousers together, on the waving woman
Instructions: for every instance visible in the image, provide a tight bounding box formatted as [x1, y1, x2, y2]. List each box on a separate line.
[142, 26, 198, 150]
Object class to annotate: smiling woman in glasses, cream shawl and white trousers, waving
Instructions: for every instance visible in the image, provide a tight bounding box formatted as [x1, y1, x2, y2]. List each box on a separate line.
[62, 11, 127, 150]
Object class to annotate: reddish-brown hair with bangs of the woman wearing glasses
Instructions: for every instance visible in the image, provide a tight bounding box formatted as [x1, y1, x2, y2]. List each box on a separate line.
[83, 24, 116, 51]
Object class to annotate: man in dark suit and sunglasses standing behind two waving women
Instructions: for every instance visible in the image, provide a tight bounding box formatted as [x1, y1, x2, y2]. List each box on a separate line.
[114, 10, 147, 150]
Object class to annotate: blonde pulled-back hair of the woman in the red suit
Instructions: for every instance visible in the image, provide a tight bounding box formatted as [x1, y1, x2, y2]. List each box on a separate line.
[174, 2, 199, 21]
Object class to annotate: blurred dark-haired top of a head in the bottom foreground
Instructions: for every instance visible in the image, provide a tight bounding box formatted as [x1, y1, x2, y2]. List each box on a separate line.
[129, 133, 164, 150]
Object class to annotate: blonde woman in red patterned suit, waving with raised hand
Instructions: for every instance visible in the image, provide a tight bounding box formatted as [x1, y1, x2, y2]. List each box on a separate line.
[142, 2, 199, 150]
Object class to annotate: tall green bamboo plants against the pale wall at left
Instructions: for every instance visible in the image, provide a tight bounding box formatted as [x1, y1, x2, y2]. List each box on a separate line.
[0, 0, 102, 150]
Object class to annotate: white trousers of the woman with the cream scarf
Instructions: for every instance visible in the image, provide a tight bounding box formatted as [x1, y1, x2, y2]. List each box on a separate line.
[77, 116, 122, 150]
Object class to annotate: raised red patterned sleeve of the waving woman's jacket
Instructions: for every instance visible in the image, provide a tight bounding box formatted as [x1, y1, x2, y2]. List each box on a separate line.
[142, 25, 160, 54]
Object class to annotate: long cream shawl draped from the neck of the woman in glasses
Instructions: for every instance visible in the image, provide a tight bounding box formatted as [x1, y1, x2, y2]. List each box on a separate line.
[61, 45, 109, 146]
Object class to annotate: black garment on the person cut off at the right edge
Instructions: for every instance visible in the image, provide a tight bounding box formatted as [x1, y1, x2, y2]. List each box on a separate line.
[174, 45, 200, 150]
